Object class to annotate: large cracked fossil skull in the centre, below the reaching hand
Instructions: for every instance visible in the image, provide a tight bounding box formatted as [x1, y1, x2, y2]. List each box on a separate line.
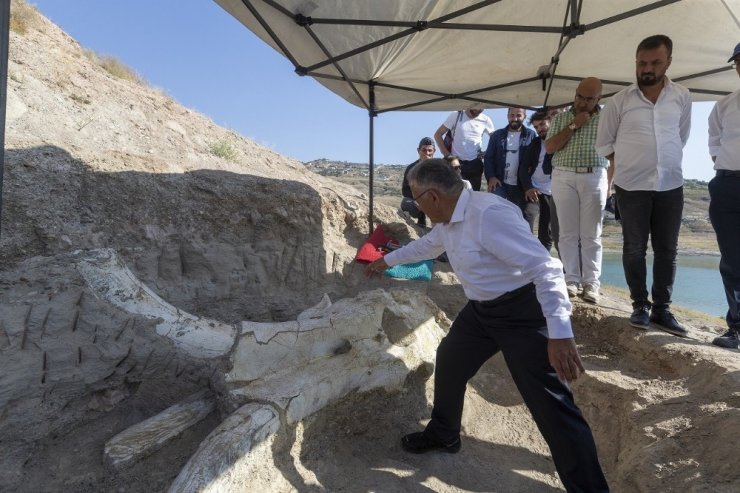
[226, 290, 443, 423]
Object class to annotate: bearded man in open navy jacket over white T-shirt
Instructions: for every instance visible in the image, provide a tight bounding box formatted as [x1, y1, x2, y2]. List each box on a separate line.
[483, 108, 535, 209]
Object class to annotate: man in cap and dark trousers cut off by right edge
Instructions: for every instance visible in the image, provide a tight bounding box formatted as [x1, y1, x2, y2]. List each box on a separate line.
[709, 43, 740, 349]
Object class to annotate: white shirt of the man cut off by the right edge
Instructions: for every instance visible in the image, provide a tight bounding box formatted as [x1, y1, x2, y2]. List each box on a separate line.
[709, 91, 740, 171]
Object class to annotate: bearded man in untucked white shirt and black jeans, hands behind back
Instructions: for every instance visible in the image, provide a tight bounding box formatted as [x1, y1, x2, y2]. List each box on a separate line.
[596, 34, 691, 337]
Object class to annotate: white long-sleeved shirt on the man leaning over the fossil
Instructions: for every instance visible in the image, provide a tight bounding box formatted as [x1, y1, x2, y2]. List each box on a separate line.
[384, 190, 573, 339]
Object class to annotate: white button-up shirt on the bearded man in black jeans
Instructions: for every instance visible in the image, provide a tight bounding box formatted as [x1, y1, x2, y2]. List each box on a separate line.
[596, 77, 691, 192]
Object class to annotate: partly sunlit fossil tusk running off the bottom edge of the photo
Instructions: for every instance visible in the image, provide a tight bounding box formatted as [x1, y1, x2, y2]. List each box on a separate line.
[169, 404, 280, 493]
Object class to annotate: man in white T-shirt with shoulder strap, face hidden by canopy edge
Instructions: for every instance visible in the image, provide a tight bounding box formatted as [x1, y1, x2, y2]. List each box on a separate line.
[434, 108, 495, 191]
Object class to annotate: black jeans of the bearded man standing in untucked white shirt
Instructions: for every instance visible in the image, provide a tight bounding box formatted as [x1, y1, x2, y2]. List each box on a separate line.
[614, 186, 683, 311]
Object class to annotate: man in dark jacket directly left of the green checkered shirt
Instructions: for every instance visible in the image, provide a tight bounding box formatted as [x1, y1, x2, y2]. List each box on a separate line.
[519, 110, 558, 251]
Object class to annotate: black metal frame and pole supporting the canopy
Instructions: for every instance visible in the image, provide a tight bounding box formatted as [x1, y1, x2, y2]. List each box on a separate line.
[216, 0, 731, 231]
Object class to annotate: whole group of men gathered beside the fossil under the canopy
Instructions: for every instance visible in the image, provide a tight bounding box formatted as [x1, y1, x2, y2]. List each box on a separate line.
[378, 35, 740, 492]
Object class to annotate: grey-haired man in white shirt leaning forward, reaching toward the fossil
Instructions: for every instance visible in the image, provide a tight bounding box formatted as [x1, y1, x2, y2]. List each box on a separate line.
[366, 159, 608, 492]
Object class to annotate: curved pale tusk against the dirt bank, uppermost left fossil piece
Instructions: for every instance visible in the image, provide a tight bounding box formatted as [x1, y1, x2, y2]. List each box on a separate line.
[77, 249, 236, 358]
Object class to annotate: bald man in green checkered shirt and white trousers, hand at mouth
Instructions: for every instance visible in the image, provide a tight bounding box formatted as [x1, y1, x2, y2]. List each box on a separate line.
[545, 77, 610, 303]
